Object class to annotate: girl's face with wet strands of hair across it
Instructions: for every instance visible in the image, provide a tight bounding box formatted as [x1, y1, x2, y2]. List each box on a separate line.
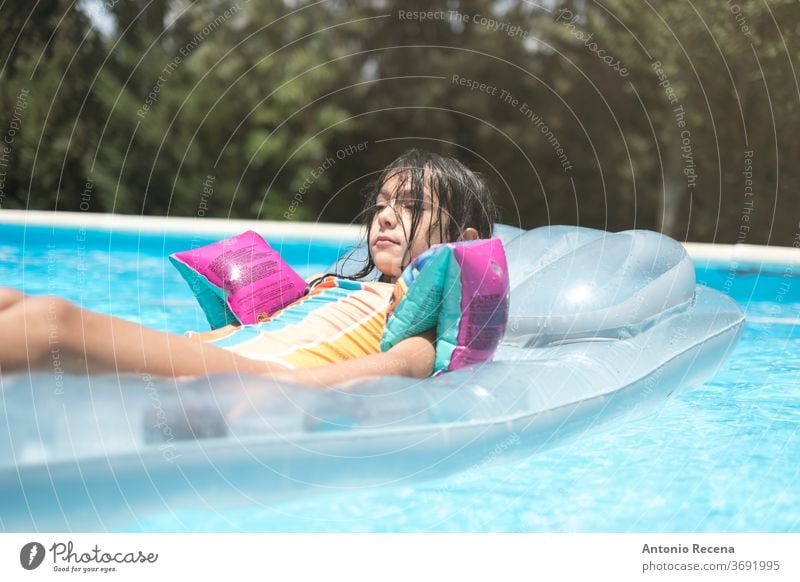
[369, 172, 443, 281]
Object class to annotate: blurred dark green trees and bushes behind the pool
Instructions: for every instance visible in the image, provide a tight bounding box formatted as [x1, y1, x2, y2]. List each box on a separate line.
[0, 0, 800, 245]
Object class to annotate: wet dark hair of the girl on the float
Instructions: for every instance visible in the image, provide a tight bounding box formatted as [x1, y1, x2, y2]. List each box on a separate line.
[348, 149, 498, 279]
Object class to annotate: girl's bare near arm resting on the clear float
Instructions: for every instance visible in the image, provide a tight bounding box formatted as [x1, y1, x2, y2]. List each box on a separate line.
[276, 329, 436, 388]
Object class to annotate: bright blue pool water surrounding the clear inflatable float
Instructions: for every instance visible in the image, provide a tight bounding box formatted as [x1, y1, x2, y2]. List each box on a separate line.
[0, 226, 800, 532]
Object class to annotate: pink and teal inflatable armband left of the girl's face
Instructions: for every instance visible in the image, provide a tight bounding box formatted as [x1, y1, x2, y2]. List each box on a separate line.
[169, 230, 306, 329]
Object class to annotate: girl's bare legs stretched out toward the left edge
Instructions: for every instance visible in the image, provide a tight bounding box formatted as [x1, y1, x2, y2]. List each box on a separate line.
[0, 294, 286, 376]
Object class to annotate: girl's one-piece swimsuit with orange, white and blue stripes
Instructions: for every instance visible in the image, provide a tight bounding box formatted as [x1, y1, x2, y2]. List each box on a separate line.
[198, 275, 394, 369]
